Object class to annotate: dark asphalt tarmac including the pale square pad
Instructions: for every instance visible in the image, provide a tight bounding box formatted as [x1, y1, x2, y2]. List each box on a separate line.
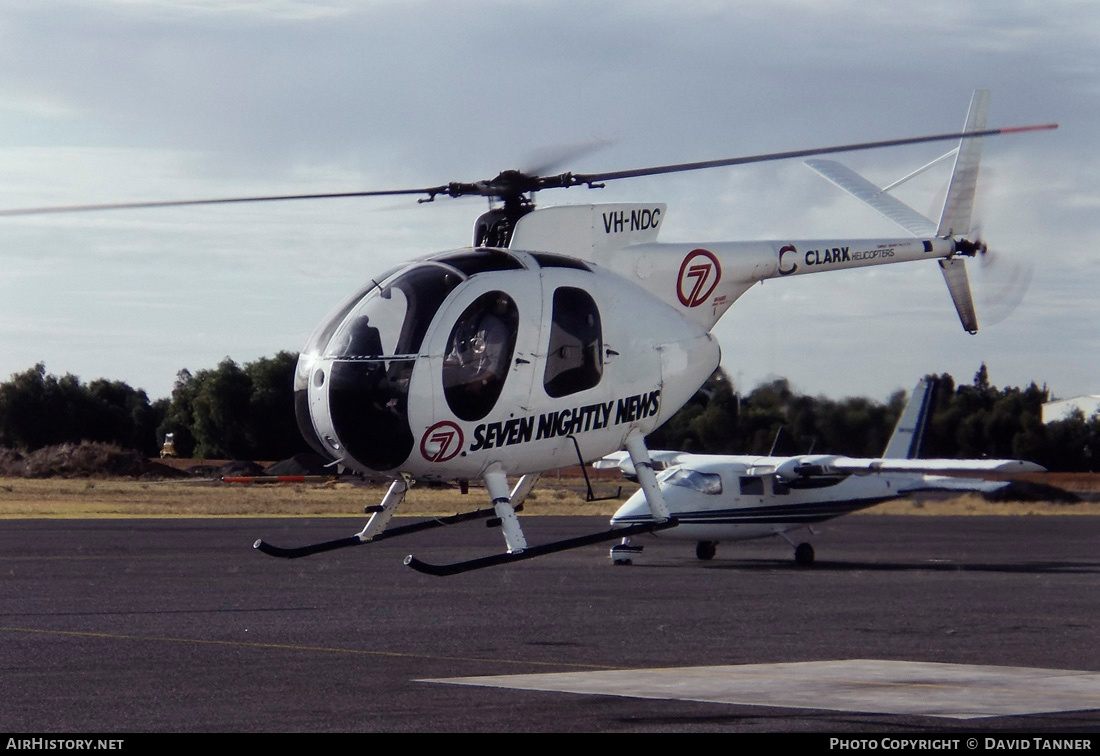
[0, 516, 1100, 734]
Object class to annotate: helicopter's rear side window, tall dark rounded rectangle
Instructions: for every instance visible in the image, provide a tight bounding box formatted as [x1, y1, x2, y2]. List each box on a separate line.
[542, 286, 604, 397]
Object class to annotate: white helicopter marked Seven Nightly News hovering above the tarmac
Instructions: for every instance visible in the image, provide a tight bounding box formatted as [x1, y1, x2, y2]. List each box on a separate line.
[0, 92, 1056, 574]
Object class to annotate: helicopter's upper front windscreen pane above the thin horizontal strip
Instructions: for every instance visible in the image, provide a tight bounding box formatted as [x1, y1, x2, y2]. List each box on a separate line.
[325, 263, 464, 359]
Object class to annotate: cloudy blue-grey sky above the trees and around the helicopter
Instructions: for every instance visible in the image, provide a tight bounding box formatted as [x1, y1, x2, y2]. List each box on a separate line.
[0, 0, 1100, 399]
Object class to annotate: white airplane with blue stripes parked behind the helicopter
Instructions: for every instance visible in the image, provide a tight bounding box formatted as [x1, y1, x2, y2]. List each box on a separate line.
[593, 379, 1045, 567]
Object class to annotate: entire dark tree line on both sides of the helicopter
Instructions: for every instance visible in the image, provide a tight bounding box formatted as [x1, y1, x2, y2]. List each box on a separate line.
[0, 352, 1100, 471]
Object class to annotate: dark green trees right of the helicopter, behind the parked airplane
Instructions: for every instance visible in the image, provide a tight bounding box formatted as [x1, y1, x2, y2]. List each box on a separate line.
[648, 364, 1100, 472]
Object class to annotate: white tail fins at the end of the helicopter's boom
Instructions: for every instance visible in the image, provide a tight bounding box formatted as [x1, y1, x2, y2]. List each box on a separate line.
[805, 89, 990, 333]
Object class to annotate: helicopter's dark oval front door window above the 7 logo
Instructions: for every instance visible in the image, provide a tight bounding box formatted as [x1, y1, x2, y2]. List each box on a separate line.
[443, 292, 519, 420]
